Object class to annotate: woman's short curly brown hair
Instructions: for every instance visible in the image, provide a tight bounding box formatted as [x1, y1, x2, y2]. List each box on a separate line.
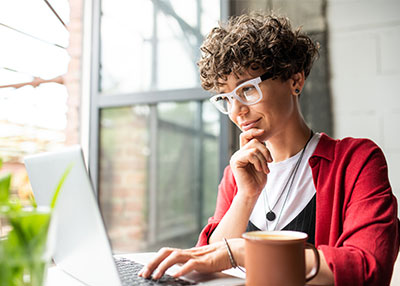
[198, 12, 319, 90]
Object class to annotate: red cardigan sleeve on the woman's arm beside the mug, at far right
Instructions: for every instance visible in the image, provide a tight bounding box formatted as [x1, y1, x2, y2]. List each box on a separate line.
[319, 140, 399, 286]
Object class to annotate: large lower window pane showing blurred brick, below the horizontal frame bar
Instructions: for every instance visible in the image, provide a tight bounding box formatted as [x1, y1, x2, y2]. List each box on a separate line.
[99, 102, 219, 252]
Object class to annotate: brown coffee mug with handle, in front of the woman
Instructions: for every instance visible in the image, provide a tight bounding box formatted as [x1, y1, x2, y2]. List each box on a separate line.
[243, 230, 319, 286]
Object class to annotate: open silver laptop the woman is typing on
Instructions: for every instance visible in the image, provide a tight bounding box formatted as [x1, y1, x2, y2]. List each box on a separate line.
[24, 146, 244, 286]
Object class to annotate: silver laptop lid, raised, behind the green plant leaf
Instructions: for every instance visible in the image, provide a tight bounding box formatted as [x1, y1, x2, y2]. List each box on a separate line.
[25, 146, 121, 286]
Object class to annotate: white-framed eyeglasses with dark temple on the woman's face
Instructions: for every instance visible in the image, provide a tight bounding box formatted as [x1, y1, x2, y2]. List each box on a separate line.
[210, 72, 272, 114]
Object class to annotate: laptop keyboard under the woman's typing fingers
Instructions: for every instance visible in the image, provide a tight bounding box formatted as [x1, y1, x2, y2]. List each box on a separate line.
[115, 258, 195, 286]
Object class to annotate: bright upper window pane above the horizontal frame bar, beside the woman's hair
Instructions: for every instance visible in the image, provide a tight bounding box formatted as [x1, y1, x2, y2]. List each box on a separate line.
[100, 0, 219, 94]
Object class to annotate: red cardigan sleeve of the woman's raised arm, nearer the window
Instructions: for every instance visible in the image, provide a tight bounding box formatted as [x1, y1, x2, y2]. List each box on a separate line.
[196, 166, 237, 246]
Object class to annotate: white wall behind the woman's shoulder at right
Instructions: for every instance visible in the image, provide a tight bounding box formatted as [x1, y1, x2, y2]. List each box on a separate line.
[327, 0, 400, 285]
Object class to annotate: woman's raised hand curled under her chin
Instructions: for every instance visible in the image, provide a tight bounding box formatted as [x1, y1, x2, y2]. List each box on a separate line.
[230, 128, 272, 197]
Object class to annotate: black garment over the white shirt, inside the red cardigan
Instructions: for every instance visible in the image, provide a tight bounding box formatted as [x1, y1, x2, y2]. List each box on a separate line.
[246, 195, 316, 244]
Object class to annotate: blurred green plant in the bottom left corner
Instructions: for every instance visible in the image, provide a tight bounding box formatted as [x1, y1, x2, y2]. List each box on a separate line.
[0, 159, 71, 286]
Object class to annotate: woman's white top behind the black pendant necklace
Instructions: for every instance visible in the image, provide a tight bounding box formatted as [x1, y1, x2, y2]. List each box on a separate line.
[250, 133, 321, 230]
